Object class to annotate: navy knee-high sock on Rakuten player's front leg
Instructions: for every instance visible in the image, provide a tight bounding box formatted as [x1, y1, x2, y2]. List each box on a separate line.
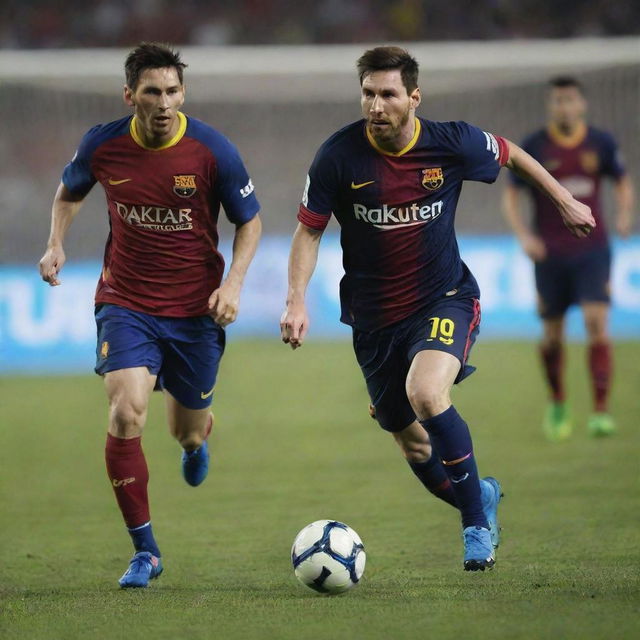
[420, 405, 489, 529]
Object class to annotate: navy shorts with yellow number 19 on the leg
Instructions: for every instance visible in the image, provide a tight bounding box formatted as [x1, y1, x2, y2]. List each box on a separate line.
[353, 298, 480, 432]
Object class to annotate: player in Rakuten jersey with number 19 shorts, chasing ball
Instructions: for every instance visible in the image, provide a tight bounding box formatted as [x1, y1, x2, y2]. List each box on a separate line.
[281, 47, 594, 571]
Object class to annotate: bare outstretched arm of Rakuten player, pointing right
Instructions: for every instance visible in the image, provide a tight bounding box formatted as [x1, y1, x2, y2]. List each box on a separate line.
[505, 139, 596, 238]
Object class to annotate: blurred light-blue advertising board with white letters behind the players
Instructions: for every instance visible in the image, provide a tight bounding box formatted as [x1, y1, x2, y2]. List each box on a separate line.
[0, 232, 640, 374]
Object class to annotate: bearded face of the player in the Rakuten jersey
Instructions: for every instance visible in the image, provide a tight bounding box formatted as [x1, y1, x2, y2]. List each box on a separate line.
[360, 69, 420, 151]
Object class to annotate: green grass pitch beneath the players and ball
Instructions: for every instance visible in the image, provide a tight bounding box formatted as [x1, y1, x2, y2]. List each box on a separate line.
[0, 340, 640, 640]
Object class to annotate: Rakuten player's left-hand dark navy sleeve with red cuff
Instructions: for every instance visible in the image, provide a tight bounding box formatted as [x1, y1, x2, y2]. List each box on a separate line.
[298, 147, 338, 230]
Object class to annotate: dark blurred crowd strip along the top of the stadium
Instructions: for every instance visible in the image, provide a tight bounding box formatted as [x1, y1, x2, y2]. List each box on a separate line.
[0, 0, 640, 49]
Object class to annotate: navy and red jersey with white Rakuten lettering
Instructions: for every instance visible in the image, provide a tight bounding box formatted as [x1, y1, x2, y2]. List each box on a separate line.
[298, 118, 508, 331]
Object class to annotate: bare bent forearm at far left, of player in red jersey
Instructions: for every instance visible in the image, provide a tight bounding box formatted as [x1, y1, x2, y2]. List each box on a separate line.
[40, 182, 85, 287]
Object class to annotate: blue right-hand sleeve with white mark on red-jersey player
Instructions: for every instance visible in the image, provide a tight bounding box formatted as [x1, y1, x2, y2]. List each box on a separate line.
[216, 139, 260, 224]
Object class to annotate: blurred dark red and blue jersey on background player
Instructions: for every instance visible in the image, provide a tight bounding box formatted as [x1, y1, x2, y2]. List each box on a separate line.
[511, 125, 625, 255]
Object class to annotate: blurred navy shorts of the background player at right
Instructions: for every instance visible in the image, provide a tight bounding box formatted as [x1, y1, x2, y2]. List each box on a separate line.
[535, 247, 611, 318]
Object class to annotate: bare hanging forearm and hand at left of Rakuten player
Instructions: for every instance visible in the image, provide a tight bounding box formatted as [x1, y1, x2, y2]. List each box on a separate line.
[280, 222, 324, 349]
